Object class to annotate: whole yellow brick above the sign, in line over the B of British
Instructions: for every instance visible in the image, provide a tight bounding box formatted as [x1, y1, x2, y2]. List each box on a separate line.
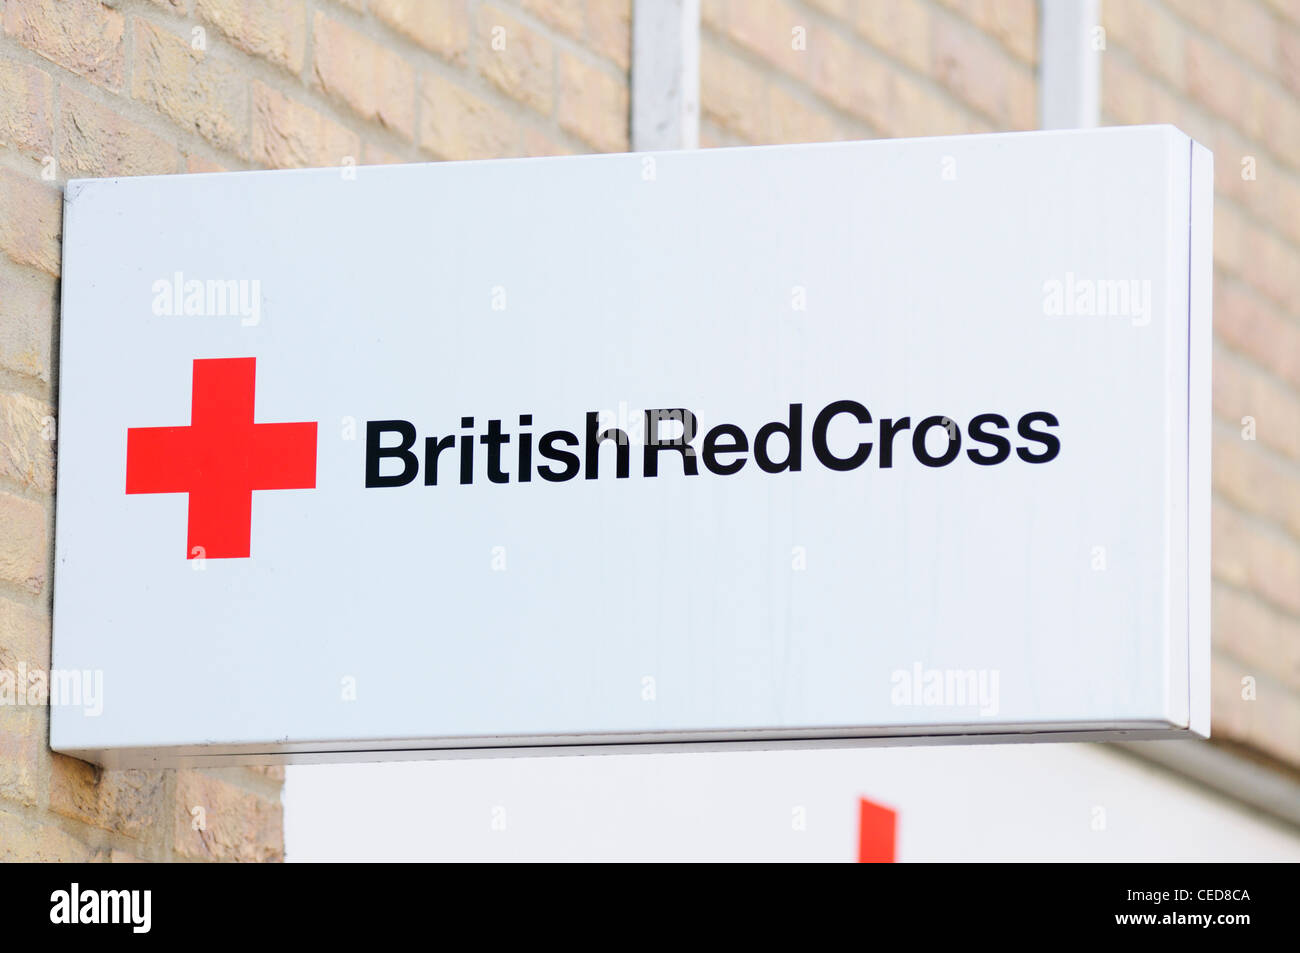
[312, 13, 415, 139]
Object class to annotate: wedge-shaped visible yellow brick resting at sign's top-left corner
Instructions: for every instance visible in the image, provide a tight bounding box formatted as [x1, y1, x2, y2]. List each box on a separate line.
[59, 83, 177, 178]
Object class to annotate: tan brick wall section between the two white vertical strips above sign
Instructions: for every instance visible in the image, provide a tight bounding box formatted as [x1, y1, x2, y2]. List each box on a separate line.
[699, 0, 1037, 146]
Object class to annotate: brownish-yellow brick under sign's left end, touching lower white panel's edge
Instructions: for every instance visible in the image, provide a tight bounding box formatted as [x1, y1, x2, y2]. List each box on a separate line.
[173, 771, 285, 862]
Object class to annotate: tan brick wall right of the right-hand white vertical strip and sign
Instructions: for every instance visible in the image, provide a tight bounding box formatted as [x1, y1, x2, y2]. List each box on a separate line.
[1101, 0, 1300, 767]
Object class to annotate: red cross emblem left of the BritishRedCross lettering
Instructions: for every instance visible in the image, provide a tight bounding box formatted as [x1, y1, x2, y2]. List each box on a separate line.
[126, 358, 316, 559]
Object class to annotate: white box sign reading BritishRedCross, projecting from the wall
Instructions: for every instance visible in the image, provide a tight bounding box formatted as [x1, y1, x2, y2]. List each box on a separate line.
[51, 127, 1212, 766]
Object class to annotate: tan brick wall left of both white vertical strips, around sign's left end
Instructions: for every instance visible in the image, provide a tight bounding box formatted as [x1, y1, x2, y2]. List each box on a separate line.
[0, 0, 631, 861]
